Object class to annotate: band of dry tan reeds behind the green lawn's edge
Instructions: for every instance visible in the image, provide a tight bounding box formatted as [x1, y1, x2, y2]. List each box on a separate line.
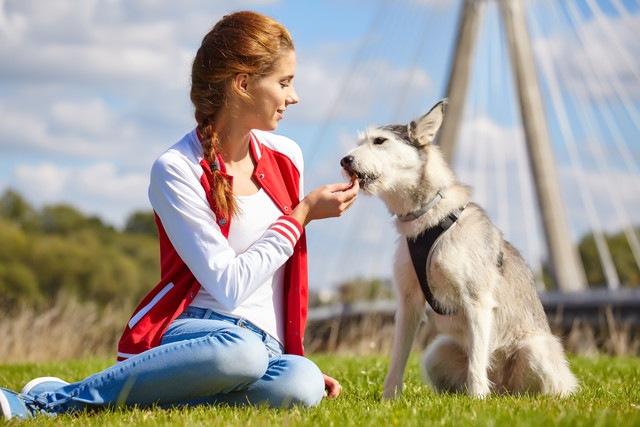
[0, 298, 640, 363]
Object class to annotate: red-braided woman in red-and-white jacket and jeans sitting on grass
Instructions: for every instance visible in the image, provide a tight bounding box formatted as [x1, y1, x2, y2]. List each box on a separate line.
[0, 12, 358, 418]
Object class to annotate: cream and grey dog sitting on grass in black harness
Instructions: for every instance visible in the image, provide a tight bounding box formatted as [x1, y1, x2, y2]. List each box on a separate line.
[340, 99, 578, 399]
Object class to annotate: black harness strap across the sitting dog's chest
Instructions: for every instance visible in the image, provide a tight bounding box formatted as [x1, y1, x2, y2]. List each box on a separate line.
[407, 207, 464, 315]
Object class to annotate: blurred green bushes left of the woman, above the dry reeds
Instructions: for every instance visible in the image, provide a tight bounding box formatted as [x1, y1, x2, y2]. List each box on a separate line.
[0, 191, 160, 307]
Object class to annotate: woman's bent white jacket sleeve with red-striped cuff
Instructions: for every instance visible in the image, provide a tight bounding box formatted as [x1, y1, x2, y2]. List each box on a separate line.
[149, 153, 302, 310]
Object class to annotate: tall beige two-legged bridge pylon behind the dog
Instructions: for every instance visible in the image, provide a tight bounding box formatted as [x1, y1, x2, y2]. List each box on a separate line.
[438, 0, 587, 292]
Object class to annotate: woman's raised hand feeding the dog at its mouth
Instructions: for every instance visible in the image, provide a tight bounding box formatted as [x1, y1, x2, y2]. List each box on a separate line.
[291, 175, 360, 227]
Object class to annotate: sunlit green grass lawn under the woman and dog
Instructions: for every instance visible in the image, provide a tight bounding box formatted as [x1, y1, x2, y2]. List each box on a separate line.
[0, 355, 640, 427]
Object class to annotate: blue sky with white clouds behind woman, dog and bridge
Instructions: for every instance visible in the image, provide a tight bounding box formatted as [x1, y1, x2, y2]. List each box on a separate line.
[0, 0, 640, 288]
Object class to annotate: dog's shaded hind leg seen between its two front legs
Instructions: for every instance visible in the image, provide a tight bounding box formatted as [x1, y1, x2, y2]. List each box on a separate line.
[421, 335, 469, 393]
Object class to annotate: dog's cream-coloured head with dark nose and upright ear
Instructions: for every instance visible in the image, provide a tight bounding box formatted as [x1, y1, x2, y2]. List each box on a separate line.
[340, 99, 446, 199]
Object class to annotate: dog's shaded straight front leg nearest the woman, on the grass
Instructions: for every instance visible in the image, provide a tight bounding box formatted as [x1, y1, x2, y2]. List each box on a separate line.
[383, 291, 424, 399]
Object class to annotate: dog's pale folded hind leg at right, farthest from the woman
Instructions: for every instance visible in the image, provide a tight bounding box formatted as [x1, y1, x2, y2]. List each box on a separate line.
[505, 334, 578, 396]
